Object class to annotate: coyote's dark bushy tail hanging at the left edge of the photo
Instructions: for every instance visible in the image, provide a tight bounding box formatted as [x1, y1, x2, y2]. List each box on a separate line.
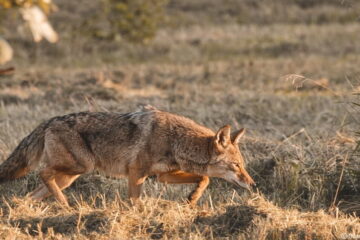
[0, 124, 45, 183]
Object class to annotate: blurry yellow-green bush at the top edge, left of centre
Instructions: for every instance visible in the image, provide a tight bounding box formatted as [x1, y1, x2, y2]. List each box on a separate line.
[104, 0, 167, 43]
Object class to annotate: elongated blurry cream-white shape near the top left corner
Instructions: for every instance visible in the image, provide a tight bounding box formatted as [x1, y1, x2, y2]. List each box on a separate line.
[21, 6, 59, 43]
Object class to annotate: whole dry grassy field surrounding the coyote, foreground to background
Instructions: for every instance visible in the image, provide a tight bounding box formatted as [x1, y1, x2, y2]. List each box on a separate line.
[0, 0, 360, 240]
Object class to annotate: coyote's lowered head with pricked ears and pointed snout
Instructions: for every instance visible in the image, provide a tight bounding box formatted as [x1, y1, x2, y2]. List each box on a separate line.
[207, 125, 255, 190]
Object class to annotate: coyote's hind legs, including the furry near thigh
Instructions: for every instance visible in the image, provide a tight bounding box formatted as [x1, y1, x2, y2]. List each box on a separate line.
[33, 128, 95, 205]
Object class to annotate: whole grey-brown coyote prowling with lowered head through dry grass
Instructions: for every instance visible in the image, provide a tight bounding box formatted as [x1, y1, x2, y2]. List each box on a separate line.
[0, 106, 254, 205]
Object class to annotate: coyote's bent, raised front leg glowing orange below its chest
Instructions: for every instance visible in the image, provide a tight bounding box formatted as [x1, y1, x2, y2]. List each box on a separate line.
[158, 171, 210, 205]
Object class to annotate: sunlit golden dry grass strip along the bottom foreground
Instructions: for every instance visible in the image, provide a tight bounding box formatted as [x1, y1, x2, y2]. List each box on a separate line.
[0, 193, 360, 239]
